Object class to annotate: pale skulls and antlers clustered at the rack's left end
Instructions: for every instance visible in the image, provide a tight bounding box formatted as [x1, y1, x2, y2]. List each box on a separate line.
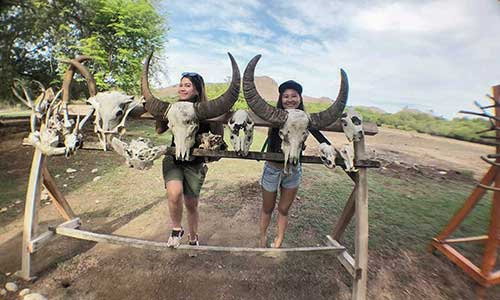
[12, 56, 138, 156]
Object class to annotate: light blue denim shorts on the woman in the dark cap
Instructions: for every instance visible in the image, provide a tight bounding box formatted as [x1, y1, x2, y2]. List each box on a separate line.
[260, 161, 302, 192]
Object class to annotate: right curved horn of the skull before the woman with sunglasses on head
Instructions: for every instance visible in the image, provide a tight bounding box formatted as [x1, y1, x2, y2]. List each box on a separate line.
[194, 52, 241, 120]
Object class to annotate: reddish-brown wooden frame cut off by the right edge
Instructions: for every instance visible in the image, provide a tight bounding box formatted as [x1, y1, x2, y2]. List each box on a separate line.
[429, 85, 500, 298]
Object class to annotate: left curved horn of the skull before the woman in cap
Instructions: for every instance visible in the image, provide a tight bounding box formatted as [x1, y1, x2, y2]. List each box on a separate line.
[243, 54, 288, 126]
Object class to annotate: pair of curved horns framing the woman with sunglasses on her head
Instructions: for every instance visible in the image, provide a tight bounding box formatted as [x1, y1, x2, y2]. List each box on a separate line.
[141, 52, 241, 121]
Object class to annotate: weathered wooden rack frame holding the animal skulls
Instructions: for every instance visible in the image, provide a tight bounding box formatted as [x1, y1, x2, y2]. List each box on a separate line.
[17, 110, 380, 300]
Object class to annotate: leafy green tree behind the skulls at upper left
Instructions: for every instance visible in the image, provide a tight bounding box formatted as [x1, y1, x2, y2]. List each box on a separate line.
[0, 0, 166, 102]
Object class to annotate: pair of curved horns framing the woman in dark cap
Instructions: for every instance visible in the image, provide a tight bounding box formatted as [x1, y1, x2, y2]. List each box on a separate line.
[243, 55, 349, 129]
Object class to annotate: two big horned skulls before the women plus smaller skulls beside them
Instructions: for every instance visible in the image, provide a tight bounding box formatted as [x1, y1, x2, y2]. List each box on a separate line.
[141, 53, 363, 171]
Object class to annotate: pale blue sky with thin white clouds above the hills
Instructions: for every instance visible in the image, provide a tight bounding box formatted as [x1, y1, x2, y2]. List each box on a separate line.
[154, 0, 500, 118]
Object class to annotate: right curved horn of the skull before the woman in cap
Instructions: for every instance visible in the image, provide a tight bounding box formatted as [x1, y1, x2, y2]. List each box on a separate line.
[309, 69, 349, 130]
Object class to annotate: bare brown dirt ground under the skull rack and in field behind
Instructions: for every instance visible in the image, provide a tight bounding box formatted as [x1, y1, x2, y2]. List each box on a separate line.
[0, 123, 500, 300]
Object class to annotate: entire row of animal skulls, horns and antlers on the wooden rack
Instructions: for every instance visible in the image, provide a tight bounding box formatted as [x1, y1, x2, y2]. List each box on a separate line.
[14, 53, 363, 170]
